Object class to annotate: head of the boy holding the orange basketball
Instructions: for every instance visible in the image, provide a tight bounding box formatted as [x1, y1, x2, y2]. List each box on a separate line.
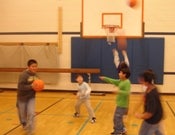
[27, 59, 38, 73]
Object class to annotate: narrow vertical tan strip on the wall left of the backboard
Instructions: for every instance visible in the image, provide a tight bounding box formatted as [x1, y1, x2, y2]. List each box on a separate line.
[58, 7, 63, 54]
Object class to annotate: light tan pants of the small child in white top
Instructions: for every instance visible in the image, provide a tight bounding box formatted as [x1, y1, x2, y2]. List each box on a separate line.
[75, 98, 95, 118]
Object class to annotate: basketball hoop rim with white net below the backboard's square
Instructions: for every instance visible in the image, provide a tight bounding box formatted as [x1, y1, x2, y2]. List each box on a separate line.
[103, 25, 119, 45]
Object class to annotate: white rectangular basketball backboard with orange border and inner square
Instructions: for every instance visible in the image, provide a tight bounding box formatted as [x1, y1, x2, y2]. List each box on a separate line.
[81, 0, 143, 38]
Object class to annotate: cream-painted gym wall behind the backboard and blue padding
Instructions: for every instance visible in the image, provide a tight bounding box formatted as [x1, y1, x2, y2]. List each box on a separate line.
[0, 0, 175, 93]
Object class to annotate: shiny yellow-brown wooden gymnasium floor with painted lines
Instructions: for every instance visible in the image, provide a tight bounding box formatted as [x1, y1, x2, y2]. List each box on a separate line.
[0, 91, 175, 135]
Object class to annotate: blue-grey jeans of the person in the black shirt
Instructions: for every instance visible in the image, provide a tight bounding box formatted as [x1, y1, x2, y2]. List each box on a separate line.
[139, 121, 164, 135]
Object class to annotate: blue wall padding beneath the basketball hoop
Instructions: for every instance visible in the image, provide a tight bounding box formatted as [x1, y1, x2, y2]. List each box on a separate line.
[71, 37, 164, 84]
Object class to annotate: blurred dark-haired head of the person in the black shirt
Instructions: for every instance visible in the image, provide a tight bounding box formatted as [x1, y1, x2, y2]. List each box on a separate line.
[139, 69, 155, 84]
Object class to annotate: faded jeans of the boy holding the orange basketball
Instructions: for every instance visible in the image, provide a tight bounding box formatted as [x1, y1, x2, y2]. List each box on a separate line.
[17, 98, 35, 131]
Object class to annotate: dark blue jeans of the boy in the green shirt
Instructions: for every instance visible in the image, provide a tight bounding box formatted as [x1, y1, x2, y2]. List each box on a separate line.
[113, 107, 128, 134]
